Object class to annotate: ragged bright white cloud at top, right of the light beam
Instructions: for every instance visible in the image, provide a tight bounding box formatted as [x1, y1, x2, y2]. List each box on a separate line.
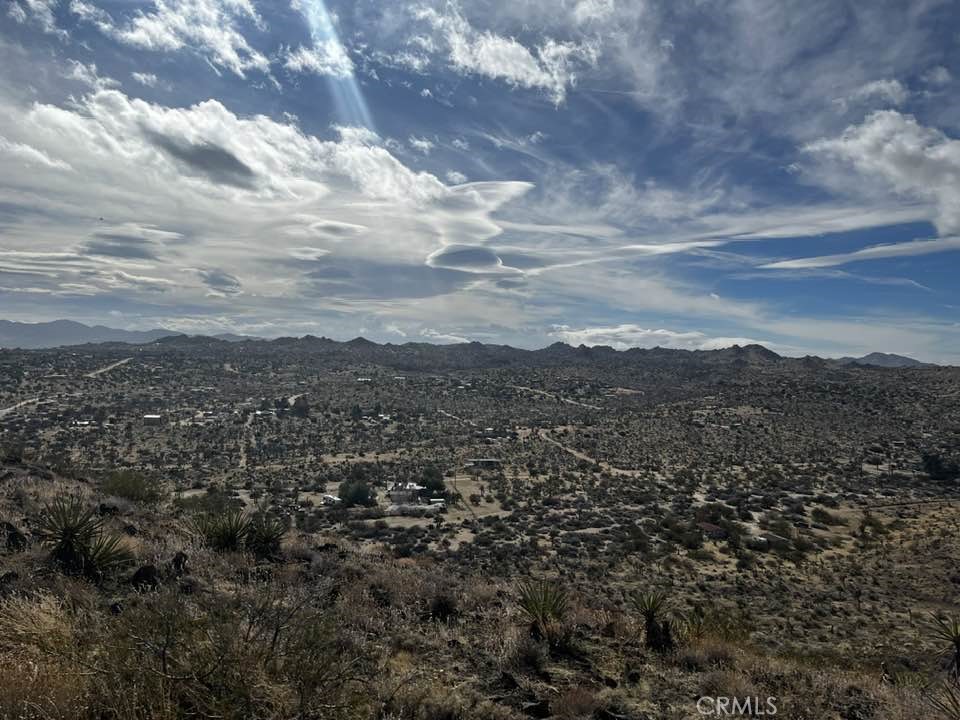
[416, 4, 599, 104]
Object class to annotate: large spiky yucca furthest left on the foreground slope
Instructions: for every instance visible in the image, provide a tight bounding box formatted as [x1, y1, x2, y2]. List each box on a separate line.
[40, 495, 133, 580]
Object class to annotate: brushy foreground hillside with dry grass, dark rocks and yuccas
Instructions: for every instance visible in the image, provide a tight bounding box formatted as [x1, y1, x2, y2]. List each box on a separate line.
[0, 458, 960, 720]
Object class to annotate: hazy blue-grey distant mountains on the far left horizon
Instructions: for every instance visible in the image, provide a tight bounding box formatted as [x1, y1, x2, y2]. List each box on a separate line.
[0, 320, 253, 350]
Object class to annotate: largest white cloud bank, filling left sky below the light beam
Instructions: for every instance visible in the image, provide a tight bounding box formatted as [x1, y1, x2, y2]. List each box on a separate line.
[0, 82, 530, 325]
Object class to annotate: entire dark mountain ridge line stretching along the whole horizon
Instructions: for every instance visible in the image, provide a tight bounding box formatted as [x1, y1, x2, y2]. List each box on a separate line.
[0, 320, 934, 369]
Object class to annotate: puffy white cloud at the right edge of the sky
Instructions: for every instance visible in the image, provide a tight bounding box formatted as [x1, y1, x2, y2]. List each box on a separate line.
[805, 110, 960, 233]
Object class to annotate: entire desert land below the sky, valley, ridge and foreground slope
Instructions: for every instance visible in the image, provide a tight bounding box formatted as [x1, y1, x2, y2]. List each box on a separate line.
[0, 338, 960, 720]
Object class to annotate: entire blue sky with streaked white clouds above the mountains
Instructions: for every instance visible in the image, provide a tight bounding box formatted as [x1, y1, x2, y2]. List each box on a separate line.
[0, 0, 960, 364]
